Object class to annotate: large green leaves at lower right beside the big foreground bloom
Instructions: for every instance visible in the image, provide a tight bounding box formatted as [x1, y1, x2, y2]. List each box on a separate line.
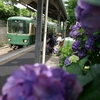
[63, 59, 100, 100]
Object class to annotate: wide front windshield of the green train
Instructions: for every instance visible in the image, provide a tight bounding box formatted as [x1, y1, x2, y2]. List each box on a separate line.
[8, 20, 29, 34]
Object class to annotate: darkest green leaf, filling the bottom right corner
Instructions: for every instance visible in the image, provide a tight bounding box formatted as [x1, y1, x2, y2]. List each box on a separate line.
[77, 74, 100, 100]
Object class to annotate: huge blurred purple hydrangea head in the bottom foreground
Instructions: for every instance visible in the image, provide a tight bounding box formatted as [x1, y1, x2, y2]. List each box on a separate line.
[0, 63, 82, 100]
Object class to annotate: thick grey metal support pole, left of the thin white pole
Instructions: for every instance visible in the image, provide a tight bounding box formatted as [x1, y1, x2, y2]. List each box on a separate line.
[35, 0, 43, 63]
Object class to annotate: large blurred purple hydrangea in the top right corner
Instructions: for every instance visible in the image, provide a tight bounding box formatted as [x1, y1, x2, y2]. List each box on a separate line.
[75, 0, 100, 35]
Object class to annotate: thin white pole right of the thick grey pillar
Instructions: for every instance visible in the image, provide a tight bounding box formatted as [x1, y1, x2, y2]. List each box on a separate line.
[42, 0, 49, 64]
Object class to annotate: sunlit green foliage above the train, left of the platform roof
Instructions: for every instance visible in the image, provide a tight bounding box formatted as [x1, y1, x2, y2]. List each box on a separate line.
[0, 0, 36, 20]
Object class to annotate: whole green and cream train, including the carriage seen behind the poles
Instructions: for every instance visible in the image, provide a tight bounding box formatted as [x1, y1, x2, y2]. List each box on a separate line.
[7, 16, 57, 49]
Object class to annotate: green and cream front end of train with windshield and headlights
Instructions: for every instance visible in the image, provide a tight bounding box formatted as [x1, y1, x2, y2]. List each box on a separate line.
[7, 17, 35, 46]
